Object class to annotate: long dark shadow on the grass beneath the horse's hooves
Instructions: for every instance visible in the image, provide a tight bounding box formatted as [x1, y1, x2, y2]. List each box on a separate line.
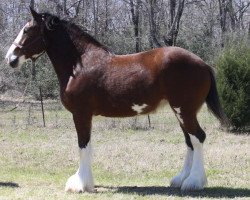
[96, 186, 250, 198]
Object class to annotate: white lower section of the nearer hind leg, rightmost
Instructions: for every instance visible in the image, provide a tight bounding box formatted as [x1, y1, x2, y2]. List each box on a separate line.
[181, 134, 207, 190]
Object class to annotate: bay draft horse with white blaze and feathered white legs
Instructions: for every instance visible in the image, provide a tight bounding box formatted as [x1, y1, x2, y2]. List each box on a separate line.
[6, 9, 227, 192]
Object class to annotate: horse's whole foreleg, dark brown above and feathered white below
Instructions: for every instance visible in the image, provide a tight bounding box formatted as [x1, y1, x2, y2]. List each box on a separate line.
[65, 114, 94, 192]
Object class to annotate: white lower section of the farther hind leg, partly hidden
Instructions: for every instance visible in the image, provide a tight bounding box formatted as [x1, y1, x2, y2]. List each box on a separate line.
[170, 147, 193, 188]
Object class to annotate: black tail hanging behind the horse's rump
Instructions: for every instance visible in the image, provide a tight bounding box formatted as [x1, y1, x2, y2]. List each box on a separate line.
[206, 68, 230, 127]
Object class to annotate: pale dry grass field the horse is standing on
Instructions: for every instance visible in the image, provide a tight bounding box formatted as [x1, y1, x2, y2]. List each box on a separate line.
[0, 104, 250, 200]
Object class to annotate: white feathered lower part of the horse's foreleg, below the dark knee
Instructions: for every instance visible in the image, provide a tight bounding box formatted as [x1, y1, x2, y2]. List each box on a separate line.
[65, 144, 94, 192]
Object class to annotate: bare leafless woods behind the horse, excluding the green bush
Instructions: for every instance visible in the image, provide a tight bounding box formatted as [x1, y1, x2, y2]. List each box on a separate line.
[0, 0, 250, 98]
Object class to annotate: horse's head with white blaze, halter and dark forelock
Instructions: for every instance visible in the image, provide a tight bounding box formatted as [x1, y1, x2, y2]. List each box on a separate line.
[5, 9, 60, 68]
